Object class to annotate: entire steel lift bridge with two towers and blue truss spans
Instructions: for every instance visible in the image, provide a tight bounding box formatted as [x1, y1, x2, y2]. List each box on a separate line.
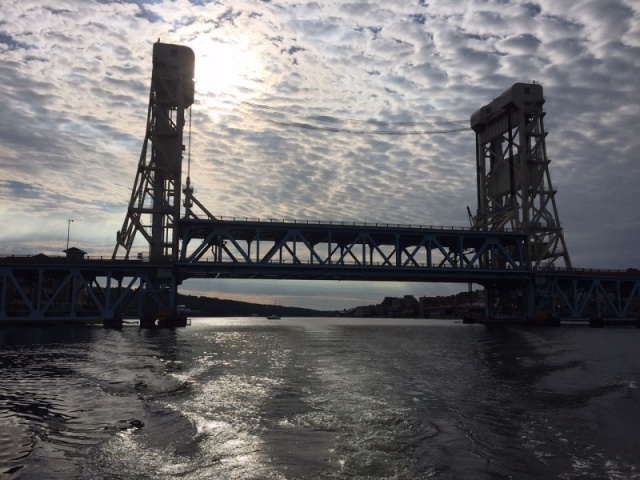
[0, 42, 640, 327]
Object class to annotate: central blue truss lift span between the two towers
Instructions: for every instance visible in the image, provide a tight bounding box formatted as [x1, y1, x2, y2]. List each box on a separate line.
[179, 219, 529, 283]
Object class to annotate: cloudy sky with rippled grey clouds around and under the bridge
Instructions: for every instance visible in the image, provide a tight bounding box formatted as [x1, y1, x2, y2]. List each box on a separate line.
[0, 0, 640, 308]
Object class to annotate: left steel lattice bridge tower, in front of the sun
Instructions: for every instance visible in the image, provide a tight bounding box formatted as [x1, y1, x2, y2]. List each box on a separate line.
[113, 43, 195, 262]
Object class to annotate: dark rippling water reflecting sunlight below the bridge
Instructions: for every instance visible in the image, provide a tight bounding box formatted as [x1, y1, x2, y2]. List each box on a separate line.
[0, 318, 640, 479]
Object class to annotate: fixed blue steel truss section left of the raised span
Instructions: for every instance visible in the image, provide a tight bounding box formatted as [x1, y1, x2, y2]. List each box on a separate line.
[0, 256, 177, 323]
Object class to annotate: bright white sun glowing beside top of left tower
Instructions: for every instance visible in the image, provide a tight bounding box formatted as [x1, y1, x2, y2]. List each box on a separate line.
[194, 41, 261, 100]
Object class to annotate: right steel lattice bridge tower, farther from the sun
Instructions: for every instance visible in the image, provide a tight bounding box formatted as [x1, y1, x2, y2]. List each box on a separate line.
[471, 83, 571, 271]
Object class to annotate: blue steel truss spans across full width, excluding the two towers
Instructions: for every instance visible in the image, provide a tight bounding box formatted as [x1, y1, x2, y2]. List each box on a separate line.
[0, 253, 640, 324]
